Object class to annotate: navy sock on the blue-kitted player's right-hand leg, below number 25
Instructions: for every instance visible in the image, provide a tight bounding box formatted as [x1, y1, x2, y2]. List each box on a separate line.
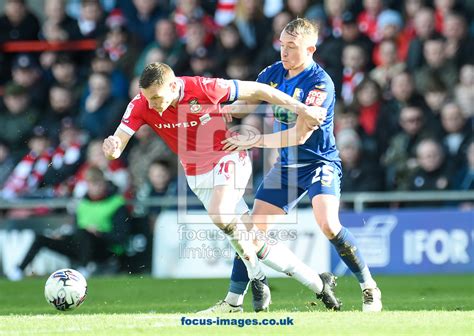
[330, 227, 371, 283]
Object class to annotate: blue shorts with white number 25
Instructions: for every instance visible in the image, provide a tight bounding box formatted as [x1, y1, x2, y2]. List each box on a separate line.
[255, 162, 342, 213]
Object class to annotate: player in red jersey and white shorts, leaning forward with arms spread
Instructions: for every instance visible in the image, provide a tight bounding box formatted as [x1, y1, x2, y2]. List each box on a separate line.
[103, 62, 326, 310]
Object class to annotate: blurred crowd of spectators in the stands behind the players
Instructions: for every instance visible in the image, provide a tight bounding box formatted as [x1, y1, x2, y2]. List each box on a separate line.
[0, 0, 474, 210]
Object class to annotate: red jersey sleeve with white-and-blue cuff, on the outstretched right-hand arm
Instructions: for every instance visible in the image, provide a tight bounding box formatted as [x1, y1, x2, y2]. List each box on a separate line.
[200, 77, 239, 105]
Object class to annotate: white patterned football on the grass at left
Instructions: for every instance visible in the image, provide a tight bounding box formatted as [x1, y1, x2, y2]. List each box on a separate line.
[44, 269, 87, 311]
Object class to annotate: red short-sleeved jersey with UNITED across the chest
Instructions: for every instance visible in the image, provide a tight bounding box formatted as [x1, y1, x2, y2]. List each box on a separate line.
[119, 77, 238, 175]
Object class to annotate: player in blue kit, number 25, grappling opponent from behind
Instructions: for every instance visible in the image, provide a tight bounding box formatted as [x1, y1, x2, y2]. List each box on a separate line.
[208, 18, 382, 312]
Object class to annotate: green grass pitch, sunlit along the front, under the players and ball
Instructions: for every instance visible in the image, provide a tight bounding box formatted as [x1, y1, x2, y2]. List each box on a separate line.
[0, 275, 474, 336]
